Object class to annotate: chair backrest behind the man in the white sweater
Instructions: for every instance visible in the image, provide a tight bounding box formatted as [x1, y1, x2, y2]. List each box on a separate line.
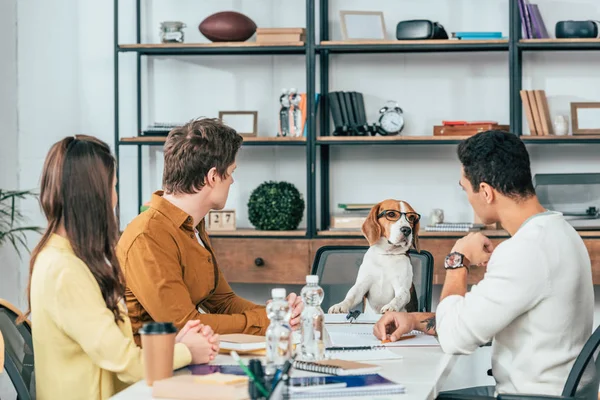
[562, 326, 600, 399]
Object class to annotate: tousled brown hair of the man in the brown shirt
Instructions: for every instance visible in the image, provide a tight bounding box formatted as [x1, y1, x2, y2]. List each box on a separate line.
[163, 118, 243, 194]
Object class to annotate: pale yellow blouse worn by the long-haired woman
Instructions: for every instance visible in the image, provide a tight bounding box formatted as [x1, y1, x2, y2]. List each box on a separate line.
[31, 235, 192, 400]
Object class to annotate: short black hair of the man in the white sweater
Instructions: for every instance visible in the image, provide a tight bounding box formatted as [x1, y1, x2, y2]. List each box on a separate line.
[458, 130, 535, 200]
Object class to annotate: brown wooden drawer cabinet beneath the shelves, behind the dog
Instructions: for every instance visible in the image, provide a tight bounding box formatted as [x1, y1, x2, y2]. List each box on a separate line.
[212, 232, 600, 285]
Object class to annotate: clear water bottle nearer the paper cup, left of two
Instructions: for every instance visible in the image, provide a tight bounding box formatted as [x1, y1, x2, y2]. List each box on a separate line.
[265, 288, 292, 376]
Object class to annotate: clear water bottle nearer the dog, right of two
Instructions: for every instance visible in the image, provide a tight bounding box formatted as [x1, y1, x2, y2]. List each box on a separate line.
[298, 275, 325, 361]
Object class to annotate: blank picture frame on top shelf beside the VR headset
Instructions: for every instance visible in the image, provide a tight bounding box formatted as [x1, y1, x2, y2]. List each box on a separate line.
[340, 10, 386, 41]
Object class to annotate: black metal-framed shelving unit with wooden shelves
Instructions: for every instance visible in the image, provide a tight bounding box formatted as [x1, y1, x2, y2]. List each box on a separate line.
[114, 0, 600, 239]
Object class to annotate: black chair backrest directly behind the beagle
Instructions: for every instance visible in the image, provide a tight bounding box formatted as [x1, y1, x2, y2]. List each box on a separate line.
[311, 246, 433, 312]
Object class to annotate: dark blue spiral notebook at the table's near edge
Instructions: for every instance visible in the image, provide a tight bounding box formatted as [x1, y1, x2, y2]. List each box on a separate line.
[289, 374, 406, 399]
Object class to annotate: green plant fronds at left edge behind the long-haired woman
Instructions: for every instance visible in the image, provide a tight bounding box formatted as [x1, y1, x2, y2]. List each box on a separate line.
[0, 189, 42, 257]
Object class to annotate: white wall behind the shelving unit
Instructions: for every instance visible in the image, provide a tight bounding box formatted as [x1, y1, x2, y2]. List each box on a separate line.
[0, 0, 600, 398]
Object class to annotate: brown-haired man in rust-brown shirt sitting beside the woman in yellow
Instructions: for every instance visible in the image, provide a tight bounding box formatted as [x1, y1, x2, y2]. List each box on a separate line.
[117, 119, 303, 344]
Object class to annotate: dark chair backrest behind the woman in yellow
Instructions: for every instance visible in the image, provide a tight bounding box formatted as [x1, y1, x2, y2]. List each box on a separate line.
[0, 299, 35, 400]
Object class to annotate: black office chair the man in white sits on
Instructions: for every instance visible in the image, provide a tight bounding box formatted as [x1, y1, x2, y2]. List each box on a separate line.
[438, 326, 600, 400]
